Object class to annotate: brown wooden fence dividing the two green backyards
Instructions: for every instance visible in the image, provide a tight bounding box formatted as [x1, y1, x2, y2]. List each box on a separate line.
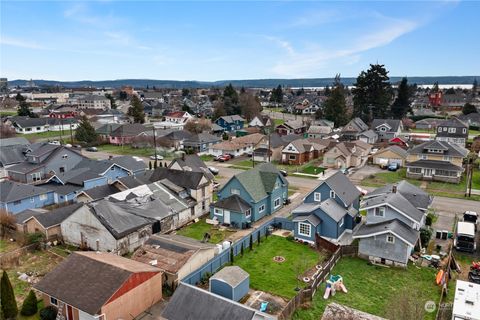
[278, 245, 358, 320]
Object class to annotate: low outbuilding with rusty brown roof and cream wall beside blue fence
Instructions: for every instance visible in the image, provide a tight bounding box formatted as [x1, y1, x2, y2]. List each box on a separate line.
[132, 234, 216, 286]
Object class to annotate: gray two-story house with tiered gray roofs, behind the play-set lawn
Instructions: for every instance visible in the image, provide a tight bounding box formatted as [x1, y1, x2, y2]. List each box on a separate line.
[353, 181, 432, 266]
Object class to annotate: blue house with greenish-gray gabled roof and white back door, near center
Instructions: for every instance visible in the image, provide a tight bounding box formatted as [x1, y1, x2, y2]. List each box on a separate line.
[210, 163, 288, 228]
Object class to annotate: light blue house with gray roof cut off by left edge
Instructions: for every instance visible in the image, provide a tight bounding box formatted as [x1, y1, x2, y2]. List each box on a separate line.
[0, 180, 54, 214]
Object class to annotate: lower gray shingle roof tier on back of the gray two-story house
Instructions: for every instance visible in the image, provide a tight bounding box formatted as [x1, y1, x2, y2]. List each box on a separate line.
[353, 219, 420, 246]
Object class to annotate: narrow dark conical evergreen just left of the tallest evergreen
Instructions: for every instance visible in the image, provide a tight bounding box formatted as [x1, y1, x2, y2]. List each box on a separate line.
[323, 74, 349, 126]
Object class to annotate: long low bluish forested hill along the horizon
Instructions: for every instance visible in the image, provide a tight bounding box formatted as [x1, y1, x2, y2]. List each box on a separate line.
[8, 76, 480, 89]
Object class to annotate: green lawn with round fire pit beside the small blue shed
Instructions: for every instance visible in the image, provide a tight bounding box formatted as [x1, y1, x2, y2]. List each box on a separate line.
[234, 236, 323, 299]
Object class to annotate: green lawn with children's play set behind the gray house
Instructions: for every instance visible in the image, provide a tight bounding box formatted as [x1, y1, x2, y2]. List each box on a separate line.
[292, 257, 440, 320]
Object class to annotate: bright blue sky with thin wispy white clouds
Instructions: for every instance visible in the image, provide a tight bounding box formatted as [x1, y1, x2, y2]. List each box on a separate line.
[0, 0, 480, 81]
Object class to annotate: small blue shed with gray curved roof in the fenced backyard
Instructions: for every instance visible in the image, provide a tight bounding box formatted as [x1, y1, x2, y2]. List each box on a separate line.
[210, 266, 250, 301]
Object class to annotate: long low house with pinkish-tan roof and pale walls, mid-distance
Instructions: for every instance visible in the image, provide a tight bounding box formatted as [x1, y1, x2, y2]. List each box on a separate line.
[208, 133, 266, 157]
